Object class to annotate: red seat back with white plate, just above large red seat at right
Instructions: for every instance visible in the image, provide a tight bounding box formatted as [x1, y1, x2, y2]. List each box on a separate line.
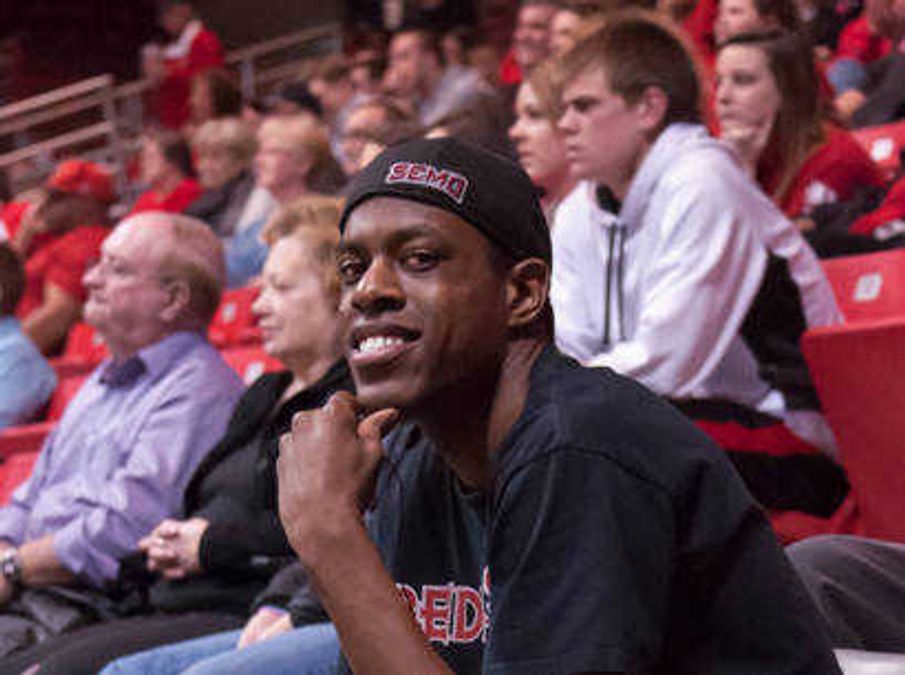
[822, 249, 905, 322]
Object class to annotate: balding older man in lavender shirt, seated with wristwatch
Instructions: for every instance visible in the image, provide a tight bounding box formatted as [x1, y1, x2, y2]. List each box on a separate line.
[0, 213, 241, 656]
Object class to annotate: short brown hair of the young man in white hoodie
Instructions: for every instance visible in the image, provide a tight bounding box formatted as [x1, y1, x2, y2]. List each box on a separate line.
[561, 9, 701, 127]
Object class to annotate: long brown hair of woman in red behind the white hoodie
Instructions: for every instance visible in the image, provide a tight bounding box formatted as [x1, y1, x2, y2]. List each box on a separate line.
[720, 30, 826, 199]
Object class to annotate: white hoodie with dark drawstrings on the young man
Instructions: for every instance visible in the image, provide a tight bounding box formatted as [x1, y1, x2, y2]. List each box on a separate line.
[551, 124, 841, 446]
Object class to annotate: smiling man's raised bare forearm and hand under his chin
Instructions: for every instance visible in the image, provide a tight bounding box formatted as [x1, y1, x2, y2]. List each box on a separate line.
[277, 393, 450, 673]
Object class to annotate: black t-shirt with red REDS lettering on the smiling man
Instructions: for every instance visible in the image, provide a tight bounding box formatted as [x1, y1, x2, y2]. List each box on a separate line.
[371, 348, 839, 675]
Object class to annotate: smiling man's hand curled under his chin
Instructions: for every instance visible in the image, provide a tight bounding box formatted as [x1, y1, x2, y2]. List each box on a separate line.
[277, 392, 399, 563]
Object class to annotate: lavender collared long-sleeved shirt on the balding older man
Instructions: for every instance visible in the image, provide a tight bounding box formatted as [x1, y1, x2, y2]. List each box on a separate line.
[0, 332, 242, 585]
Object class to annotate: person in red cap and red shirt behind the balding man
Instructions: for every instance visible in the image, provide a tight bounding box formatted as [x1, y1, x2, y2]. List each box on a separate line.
[12, 159, 114, 355]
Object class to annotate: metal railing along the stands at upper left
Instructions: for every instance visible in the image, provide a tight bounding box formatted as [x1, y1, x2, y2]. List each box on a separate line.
[0, 23, 341, 197]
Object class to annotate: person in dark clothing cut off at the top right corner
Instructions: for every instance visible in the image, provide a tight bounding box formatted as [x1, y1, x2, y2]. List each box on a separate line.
[835, 0, 905, 127]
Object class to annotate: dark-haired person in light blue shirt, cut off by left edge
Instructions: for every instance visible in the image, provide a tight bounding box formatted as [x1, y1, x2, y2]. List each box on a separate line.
[0, 243, 57, 429]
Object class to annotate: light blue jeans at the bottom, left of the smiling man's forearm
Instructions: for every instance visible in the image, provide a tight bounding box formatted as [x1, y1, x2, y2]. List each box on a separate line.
[101, 623, 339, 675]
